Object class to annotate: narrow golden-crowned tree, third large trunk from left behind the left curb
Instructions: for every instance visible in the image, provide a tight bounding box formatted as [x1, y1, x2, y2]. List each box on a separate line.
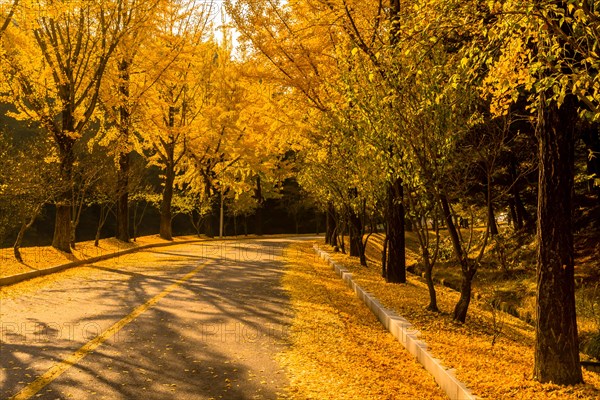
[140, 3, 217, 240]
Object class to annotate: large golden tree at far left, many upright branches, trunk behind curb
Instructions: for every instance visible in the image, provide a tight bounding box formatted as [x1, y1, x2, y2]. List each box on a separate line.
[1, 0, 135, 252]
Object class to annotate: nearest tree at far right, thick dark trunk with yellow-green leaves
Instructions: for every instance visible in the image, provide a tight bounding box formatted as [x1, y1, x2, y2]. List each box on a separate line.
[465, 0, 600, 384]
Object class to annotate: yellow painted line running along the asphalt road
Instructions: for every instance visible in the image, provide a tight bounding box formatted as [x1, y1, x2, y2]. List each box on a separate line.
[10, 261, 208, 400]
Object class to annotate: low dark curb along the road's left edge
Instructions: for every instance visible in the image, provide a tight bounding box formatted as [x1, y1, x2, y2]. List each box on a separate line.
[0, 239, 208, 286]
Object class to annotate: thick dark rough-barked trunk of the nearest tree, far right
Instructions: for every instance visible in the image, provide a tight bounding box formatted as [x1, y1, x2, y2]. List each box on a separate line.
[534, 96, 583, 385]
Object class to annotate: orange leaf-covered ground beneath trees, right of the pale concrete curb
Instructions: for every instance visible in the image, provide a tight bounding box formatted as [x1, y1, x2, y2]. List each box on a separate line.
[314, 241, 600, 400]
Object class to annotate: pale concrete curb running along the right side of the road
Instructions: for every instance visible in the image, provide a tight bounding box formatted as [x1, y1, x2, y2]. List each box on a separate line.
[314, 245, 477, 400]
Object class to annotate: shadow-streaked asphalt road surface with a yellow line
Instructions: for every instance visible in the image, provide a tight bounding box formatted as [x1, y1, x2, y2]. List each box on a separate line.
[0, 239, 300, 399]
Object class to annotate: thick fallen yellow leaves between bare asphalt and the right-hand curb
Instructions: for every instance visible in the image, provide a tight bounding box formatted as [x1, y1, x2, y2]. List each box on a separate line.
[279, 243, 446, 400]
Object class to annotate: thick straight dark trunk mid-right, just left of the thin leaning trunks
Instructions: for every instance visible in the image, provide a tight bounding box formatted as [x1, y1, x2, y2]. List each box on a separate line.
[384, 178, 406, 283]
